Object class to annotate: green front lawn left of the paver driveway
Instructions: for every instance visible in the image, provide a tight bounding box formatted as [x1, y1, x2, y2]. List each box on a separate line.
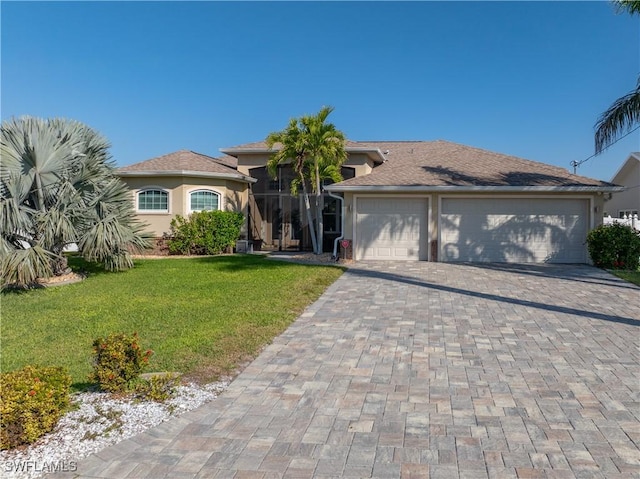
[0, 255, 342, 389]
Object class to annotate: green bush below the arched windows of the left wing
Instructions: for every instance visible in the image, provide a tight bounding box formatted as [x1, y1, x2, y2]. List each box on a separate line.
[169, 211, 244, 255]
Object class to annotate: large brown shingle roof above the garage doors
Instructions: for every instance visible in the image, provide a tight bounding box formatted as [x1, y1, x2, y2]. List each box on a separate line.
[326, 140, 622, 191]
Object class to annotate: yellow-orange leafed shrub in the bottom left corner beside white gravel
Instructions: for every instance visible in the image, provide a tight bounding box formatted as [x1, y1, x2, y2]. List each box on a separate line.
[0, 366, 71, 449]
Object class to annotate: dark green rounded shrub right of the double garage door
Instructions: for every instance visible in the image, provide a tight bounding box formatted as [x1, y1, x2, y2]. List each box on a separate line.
[587, 223, 640, 271]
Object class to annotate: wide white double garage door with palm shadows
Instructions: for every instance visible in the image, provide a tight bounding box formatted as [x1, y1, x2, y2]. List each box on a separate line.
[440, 198, 589, 263]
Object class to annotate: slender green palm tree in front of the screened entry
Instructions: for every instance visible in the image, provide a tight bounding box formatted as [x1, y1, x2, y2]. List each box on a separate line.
[266, 107, 347, 254]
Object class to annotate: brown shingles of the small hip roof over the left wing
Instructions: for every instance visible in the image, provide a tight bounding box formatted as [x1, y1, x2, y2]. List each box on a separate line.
[118, 150, 239, 175]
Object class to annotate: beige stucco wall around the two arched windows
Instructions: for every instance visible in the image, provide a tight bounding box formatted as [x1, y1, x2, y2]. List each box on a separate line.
[122, 176, 248, 237]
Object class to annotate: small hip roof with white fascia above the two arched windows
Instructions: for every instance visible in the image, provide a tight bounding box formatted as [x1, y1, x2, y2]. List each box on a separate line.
[116, 150, 256, 183]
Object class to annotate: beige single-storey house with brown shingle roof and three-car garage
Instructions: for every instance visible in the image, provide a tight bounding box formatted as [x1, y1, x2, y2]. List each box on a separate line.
[119, 141, 622, 263]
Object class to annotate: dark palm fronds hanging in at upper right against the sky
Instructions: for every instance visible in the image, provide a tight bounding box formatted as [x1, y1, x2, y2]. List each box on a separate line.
[595, 0, 640, 155]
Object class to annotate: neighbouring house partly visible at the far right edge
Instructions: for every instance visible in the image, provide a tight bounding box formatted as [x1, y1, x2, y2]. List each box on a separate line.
[604, 152, 640, 218]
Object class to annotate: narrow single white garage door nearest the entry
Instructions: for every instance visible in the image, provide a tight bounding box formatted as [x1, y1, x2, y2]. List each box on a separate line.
[355, 197, 428, 260]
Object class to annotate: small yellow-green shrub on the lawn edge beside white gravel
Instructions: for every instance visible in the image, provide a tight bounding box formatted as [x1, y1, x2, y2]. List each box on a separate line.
[89, 333, 153, 393]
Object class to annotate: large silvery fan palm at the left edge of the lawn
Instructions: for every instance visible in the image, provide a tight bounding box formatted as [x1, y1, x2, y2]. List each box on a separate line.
[0, 117, 147, 285]
